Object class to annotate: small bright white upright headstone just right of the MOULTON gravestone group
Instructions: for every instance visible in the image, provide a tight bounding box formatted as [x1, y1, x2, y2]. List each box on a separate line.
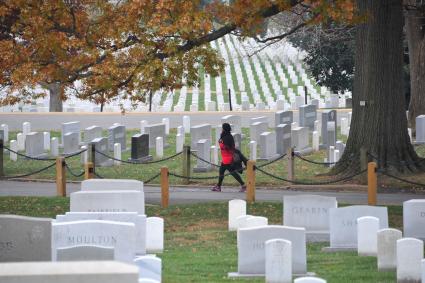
[146, 217, 164, 253]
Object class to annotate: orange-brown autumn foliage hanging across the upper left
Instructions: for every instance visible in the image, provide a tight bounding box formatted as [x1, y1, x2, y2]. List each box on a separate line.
[0, 0, 353, 111]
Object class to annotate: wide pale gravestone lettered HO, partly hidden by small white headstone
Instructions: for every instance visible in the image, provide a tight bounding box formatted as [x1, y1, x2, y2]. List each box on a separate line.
[229, 225, 307, 278]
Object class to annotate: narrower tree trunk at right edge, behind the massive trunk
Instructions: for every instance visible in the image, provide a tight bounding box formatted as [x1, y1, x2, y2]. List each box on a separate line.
[406, 3, 425, 131]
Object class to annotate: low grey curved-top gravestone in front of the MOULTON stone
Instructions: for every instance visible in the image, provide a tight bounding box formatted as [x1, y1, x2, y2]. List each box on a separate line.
[56, 245, 114, 261]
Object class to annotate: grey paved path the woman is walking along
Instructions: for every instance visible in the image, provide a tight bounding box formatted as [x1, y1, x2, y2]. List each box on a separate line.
[0, 181, 425, 205]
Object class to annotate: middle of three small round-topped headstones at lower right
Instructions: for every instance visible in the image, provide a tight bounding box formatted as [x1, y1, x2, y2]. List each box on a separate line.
[377, 229, 402, 271]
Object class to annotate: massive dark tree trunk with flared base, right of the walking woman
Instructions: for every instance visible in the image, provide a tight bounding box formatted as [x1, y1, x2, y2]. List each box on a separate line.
[333, 0, 418, 174]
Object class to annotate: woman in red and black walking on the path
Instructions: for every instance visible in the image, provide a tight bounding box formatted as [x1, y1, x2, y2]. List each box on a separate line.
[212, 123, 246, 192]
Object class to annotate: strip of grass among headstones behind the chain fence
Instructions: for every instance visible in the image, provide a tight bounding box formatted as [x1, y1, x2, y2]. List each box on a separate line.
[4, 128, 425, 190]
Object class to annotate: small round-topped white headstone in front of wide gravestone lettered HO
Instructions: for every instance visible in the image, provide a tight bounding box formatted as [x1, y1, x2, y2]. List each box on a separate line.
[265, 239, 292, 283]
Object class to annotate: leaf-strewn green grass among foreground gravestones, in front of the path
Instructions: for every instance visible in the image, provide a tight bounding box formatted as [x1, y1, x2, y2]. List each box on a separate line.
[0, 197, 403, 283]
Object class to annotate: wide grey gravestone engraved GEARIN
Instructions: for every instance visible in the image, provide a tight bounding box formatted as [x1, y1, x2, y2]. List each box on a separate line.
[283, 195, 338, 242]
